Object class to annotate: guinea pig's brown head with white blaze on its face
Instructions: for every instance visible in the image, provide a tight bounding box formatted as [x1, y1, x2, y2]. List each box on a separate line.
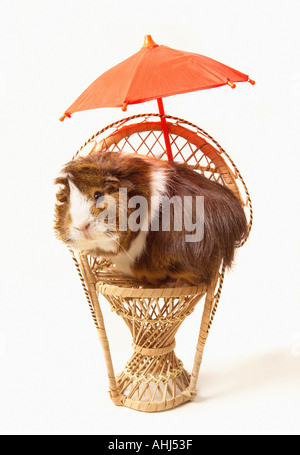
[54, 152, 148, 254]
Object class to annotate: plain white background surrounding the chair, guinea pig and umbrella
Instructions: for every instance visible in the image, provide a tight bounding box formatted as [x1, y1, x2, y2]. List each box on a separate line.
[0, 0, 300, 435]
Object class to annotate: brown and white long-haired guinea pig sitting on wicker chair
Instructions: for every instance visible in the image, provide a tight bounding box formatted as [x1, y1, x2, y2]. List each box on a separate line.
[54, 152, 248, 285]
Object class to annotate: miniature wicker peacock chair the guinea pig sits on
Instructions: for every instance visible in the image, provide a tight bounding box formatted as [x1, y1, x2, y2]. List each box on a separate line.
[65, 114, 252, 412]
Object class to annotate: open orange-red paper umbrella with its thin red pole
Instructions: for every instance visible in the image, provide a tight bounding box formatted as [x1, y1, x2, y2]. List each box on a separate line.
[60, 35, 255, 159]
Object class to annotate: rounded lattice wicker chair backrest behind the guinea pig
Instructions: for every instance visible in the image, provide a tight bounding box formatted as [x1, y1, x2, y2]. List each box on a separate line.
[74, 114, 253, 245]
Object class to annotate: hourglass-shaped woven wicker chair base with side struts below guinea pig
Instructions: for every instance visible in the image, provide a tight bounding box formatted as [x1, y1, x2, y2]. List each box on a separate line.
[73, 253, 222, 412]
